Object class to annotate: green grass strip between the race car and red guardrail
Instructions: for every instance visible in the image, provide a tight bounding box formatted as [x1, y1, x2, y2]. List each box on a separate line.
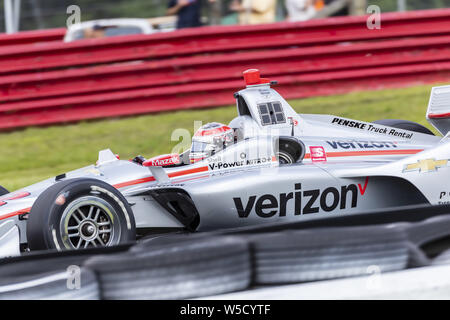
[0, 86, 440, 190]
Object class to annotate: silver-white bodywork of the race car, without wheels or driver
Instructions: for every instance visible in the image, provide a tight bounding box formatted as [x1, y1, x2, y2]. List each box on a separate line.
[0, 75, 450, 258]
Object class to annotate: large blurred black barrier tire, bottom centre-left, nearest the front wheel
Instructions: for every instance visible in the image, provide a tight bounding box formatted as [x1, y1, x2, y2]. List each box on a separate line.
[84, 236, 251, 300]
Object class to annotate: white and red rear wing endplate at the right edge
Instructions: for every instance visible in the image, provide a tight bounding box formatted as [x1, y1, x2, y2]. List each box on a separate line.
[426, 85, 450, 136]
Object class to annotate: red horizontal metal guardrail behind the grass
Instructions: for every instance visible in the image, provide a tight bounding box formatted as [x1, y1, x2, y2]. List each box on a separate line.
[0, 9, 450, 130]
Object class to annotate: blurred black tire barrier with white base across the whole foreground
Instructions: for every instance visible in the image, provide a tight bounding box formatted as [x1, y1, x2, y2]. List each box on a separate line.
[0, 206, 450, 300]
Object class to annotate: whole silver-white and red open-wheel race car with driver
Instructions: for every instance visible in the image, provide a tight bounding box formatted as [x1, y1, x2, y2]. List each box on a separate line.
[0, 69, 450, 256]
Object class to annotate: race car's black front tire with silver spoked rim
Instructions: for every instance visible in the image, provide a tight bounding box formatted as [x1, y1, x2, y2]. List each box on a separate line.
[26, 178, 136, 251]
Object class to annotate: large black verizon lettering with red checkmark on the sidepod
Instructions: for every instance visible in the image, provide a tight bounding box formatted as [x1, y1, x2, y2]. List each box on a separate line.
[233, 178, 369, 218]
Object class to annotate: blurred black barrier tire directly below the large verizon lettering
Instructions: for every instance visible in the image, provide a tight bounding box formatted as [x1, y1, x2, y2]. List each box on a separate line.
[250, 227, 408, 285]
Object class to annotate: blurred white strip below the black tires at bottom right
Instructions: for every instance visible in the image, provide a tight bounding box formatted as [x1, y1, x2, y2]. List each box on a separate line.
[201, 265, 450, 301]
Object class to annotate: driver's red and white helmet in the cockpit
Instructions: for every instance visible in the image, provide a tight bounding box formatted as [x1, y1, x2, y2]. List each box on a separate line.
[189, 122, 234, 163]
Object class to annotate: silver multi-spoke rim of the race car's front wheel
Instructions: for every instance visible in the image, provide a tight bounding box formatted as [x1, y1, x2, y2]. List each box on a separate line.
[60, 196, 120, 250]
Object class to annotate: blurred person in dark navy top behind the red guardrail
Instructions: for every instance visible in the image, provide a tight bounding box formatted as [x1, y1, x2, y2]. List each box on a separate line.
[167, 0, 202, 29]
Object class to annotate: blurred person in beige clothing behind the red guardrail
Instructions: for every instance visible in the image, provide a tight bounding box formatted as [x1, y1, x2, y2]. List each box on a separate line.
[230, 0, 277, 24]
